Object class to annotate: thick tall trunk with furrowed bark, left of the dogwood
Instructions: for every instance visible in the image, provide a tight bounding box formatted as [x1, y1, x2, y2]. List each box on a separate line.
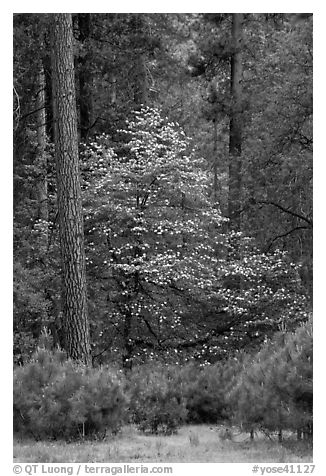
[52, 13, 90, 364]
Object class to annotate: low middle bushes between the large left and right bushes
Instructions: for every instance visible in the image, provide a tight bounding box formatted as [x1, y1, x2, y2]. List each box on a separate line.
[129, 360, 241, 434]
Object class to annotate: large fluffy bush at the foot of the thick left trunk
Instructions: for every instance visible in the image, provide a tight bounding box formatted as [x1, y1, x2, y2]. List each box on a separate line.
[14, 349, 127, 438]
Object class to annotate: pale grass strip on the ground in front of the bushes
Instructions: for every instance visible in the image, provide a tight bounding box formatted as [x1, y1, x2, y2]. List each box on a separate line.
[14, 425, 312, 463]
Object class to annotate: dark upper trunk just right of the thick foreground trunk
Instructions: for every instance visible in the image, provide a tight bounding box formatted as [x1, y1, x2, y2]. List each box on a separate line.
[78, 13, 93, 139]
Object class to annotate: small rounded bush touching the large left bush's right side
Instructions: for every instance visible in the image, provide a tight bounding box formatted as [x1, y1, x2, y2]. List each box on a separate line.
[129, 365, 187, 435]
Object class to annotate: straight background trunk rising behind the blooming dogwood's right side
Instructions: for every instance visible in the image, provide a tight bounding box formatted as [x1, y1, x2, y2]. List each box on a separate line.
[228, 13, 243, 237]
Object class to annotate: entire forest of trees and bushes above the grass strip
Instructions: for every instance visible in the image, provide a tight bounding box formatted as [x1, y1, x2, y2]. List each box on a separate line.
[13, 13, 313, 461]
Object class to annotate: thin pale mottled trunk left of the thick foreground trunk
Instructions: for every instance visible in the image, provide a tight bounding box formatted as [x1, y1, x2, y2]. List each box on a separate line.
[36, 63, 49, 254]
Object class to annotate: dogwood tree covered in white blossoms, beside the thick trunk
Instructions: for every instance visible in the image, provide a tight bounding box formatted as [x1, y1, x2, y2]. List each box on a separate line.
[83, 108, 310, 366]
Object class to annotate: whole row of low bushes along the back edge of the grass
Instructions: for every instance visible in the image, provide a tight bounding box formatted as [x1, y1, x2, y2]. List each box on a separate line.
[14, 321, 312, 438]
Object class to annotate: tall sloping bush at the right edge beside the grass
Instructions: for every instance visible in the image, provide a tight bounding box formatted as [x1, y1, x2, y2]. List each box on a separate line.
[230, 321, 312, 434]
